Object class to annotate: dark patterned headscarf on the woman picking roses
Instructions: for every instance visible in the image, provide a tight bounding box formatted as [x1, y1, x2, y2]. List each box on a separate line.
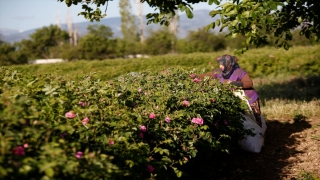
[217, 54, 240, 79]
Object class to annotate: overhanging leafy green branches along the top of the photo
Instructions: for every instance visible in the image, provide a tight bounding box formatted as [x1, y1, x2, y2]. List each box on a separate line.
[58, 0, 320, 53]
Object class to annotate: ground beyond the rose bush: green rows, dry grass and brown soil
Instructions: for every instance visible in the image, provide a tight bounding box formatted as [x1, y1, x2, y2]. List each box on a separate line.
[4, 45, 320, 180]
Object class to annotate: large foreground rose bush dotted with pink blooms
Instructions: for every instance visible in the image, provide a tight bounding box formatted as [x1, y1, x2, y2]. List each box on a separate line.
[0, 68, 250, 179]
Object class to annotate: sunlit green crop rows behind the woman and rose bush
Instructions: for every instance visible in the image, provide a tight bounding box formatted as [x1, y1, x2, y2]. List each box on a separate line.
[14, 45, 320, 80]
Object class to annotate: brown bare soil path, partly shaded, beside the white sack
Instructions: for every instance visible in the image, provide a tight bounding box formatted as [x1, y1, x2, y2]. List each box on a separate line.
[212, 118, 320, 180]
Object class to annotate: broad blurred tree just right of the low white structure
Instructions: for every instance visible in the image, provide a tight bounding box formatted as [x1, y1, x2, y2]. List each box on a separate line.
[78, 24, 116, 60]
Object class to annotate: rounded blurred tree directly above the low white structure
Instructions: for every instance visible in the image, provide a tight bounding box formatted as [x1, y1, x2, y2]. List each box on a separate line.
[19, 25, 69, 59]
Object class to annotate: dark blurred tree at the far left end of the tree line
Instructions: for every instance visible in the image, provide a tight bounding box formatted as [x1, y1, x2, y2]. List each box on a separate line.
[0, 43, 28, 66]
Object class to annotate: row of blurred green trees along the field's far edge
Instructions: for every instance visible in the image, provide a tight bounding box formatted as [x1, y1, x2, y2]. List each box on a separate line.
[0, 25, 312, 66]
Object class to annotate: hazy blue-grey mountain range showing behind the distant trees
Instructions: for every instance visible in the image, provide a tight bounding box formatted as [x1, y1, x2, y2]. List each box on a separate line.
[0, 10, 218, 43]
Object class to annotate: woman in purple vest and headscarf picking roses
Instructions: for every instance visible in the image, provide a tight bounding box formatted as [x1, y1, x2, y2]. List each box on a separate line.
[198, 55, 261, 127]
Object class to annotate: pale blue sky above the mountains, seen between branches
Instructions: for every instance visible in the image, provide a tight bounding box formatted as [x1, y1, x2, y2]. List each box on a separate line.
[0, 0, 215, 32]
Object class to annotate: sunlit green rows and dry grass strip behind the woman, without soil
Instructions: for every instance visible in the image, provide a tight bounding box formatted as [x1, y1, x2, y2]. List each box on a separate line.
[12, 45, 320, 119]
